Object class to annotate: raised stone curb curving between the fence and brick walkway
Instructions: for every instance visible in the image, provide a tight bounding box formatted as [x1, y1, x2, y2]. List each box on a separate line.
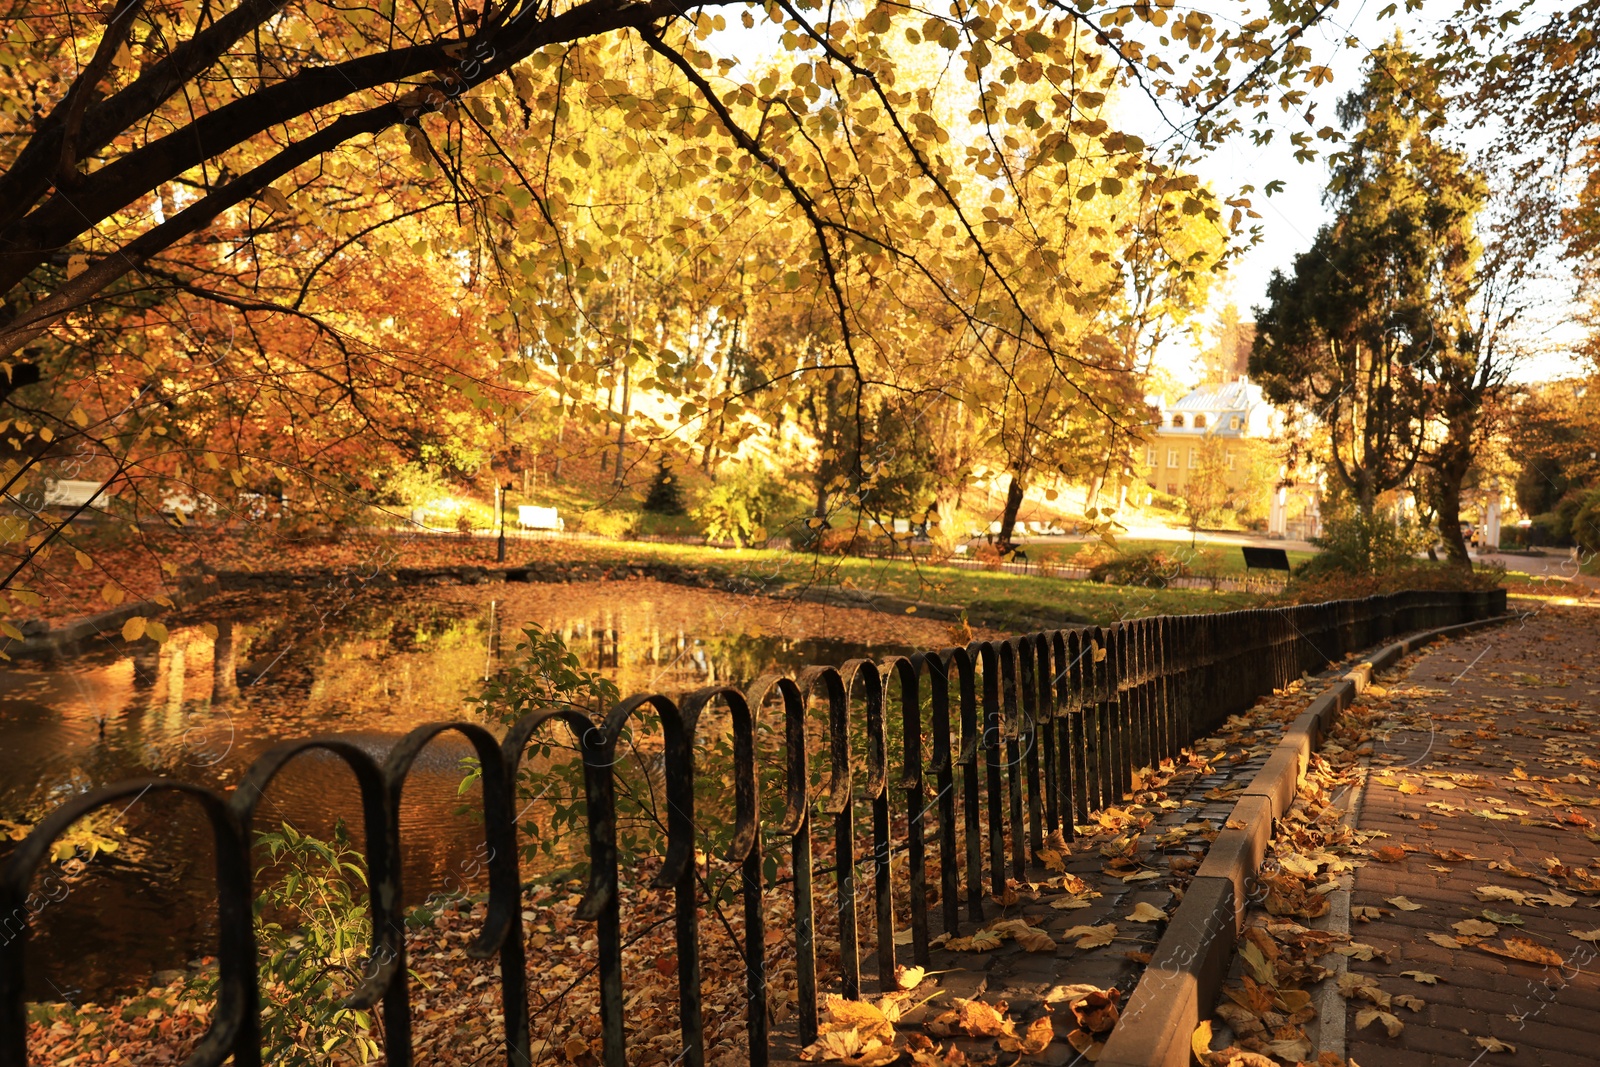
[1096, 613, 1518, 1067]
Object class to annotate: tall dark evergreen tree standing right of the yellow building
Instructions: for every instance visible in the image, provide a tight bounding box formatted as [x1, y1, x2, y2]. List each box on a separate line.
[1250, 35, 1486, 515]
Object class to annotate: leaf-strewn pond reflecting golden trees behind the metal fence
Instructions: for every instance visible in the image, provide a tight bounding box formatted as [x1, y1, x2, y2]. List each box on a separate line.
[0, 581, 950, 1001]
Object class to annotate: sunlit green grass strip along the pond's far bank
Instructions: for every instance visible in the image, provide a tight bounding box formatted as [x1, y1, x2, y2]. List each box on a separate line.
[558, 542, 1261, 625]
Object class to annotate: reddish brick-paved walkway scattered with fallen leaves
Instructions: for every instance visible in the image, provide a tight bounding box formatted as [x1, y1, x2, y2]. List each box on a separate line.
[1346, 606, 1600, 1067]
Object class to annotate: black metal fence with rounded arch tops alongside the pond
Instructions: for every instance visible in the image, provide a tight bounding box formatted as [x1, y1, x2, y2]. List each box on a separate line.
[0, 590, 1506, 1067]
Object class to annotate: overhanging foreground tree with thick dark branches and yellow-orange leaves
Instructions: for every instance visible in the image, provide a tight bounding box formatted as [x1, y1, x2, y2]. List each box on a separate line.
[0, 0, 1356, 633]
